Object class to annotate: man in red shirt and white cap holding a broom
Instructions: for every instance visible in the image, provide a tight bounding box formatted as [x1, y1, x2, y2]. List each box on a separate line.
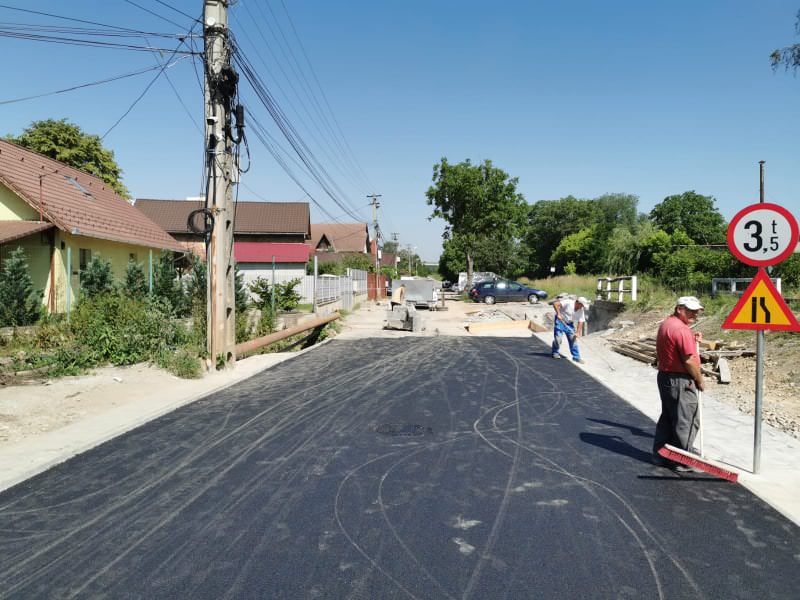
[653, 296, 705, 470]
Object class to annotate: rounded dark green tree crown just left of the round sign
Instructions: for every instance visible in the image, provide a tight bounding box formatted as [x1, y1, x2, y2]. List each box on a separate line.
[650, 191, 727, 244]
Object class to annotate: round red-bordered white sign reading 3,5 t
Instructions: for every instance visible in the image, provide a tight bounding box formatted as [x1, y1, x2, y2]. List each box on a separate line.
[728, 202, 798, 267]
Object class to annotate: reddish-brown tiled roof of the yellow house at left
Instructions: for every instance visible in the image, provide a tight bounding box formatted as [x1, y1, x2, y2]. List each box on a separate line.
[0, 140, 181, 251]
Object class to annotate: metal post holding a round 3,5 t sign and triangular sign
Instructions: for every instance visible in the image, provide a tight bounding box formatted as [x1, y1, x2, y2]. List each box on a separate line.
[722, 198, 800, 475]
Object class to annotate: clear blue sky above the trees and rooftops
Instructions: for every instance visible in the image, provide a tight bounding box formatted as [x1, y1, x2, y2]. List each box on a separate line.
[0, 0, 800, 260]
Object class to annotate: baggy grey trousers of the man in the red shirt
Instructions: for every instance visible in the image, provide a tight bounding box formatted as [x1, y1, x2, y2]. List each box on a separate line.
[653, 371, 700, 454]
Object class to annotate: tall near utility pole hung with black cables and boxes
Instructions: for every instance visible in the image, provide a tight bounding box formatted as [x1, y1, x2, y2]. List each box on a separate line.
[203, 0, 238, 368]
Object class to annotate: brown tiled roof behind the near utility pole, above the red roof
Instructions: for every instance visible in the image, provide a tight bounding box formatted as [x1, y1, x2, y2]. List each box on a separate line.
[135, 198, 311, 238]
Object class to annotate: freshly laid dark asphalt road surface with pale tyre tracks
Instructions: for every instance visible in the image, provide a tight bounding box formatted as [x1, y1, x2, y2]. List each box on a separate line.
[0, 337, 800, 599]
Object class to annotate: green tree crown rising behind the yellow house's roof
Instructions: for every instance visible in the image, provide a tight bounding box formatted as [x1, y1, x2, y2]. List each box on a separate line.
[6, 119, 130, 198]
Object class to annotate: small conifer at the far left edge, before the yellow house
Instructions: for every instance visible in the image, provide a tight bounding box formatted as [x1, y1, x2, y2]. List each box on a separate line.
[0, 247, 42, 327]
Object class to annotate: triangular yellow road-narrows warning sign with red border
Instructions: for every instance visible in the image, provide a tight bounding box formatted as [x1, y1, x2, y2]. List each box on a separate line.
[722, 269, 800, 331]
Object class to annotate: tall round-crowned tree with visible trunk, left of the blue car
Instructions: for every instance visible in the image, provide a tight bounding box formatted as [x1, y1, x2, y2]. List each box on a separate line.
[425, 158, 528, 281]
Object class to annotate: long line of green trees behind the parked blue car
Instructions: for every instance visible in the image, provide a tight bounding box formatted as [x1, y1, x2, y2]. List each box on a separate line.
[426, 158, 800, 292]
